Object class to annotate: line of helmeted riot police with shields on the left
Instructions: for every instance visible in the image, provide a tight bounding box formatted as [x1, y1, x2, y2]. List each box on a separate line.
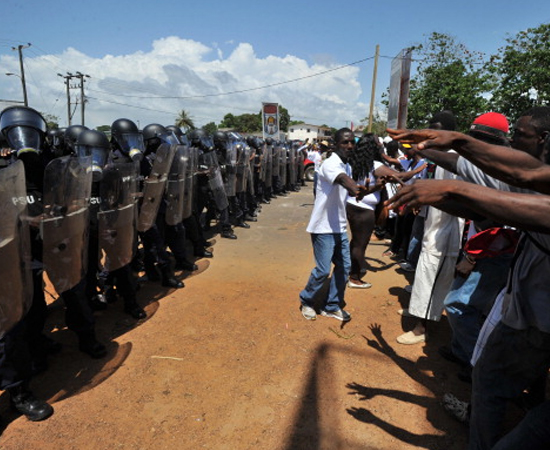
[0, 106, 307, 421]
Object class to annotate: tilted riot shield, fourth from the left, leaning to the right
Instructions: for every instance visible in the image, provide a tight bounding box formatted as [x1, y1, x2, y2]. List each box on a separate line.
[137, 144, 177, 232]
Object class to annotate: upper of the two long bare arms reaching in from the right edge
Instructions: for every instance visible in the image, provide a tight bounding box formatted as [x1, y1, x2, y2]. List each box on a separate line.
[387, 129, 550, 194]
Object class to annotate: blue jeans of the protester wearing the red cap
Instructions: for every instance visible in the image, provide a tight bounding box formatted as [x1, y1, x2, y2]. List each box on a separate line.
[444, 255, 512, 364]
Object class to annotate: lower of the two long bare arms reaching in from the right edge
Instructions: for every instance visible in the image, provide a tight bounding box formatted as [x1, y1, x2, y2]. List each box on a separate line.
[386, 180, 550, 234]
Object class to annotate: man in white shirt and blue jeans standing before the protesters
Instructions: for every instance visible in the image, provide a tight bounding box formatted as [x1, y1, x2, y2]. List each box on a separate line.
[300, 128, 367, 322]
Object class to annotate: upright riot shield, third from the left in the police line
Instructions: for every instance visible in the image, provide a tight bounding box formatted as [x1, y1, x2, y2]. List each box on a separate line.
[97, 163, 137, 271]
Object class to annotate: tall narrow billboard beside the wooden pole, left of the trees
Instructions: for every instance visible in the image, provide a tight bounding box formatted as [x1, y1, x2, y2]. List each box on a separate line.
[388, 49, 412, 128]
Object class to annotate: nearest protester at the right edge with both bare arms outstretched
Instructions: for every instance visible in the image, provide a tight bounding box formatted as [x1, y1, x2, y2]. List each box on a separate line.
[388, 107, 550, 450]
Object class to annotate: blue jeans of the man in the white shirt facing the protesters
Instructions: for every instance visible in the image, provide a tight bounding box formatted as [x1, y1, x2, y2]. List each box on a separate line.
[300, 233, 351, 311]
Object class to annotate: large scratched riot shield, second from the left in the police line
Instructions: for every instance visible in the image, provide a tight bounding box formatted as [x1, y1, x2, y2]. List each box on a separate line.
[40, 156, 92, 294]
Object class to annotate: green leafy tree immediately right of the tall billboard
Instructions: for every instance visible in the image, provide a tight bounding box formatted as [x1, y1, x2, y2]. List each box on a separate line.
[408, 32, 492, 131]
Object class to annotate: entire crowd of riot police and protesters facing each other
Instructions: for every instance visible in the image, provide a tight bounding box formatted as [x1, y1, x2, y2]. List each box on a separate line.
[0, 102, 550, 450]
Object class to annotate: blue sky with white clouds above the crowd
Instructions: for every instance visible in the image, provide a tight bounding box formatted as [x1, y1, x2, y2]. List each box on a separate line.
[0, 0, 550, 128]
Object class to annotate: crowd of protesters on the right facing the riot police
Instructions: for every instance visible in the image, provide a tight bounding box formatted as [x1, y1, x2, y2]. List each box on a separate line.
[299, 107, 550, 450]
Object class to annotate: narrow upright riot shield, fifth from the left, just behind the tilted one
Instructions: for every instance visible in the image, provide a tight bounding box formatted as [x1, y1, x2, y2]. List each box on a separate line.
[165, 145, 189, 225]
